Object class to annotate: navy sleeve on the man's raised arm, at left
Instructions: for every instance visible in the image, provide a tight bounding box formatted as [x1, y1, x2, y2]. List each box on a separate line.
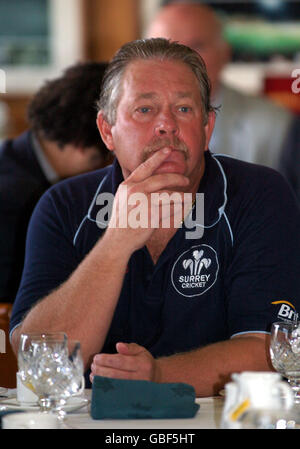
[10, 185, 78, 331]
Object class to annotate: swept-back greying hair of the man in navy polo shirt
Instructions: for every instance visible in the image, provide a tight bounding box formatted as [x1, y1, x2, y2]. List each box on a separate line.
[97, 38, 214, 125]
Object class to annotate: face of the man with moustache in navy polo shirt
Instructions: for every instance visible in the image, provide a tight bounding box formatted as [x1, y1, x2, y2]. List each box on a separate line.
[98, 59, 214, 189]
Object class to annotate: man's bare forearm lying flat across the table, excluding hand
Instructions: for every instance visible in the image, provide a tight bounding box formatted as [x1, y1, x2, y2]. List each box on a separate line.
[155, 334, 272, 396]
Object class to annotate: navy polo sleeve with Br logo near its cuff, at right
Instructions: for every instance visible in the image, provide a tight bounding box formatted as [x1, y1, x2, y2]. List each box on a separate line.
[225, 169, 300, 336]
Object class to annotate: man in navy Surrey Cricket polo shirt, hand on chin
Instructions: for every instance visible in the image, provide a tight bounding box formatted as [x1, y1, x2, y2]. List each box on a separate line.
[11, 39, 300, 396]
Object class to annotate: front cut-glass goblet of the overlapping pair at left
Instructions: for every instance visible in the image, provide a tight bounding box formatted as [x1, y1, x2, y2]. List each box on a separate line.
[30, 340, 84, 419]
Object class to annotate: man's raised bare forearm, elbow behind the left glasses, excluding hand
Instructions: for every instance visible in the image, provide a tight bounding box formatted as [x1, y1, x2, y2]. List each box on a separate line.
[12, 231, 130, 366]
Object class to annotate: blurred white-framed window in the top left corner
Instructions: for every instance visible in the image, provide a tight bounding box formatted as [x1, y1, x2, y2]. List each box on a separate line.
[0, 0, 83, 94]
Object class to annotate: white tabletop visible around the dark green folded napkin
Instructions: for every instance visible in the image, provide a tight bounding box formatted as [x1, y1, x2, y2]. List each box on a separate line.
[66, 390, 224, 429]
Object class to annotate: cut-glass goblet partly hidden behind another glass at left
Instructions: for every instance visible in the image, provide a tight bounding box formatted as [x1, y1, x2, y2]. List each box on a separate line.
[18, 332, 67, 400]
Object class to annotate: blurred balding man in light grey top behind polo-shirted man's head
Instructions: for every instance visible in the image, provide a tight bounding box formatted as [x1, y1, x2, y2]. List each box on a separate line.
[146, 1, 292, 169]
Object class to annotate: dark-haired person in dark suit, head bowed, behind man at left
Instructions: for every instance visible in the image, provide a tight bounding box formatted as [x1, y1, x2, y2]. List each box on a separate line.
[0, 63, 109, 302]
